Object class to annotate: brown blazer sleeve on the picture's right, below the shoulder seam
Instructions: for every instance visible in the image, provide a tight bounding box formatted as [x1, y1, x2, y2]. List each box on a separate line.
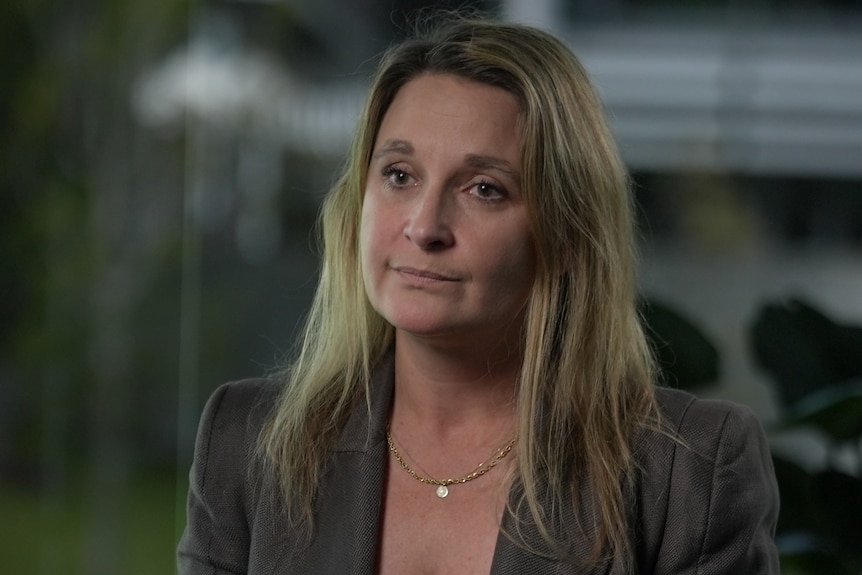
[655, 399, 779, 575]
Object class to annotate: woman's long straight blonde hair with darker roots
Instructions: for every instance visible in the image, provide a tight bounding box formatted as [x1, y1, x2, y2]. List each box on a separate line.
[259, 13, 657, 571]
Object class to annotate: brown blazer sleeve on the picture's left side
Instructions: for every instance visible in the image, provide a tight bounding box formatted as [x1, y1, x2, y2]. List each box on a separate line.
[177, 380, 268, 575]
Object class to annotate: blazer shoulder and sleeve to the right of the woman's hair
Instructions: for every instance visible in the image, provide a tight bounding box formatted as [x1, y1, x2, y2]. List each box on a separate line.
[637, 388, 778, 573]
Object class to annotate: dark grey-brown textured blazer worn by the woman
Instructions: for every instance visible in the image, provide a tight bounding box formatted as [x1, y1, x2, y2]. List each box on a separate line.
[178, 356, 779, 575]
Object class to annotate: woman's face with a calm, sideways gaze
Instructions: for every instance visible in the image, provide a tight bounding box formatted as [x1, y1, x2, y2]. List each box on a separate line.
[360, 74, 536, 345]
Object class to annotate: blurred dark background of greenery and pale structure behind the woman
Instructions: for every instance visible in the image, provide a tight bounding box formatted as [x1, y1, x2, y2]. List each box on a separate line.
[0, 0, 862, 575]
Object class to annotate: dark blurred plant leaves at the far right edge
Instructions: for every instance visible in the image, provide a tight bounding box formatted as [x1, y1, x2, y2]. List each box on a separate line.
[751, 300, 862, 574]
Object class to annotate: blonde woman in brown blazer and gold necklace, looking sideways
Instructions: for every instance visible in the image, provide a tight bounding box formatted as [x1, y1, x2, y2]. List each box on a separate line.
[179, 13, 778, 574]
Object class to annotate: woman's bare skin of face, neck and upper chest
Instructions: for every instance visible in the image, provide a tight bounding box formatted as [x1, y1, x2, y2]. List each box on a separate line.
[360, 74, 536, 574]
